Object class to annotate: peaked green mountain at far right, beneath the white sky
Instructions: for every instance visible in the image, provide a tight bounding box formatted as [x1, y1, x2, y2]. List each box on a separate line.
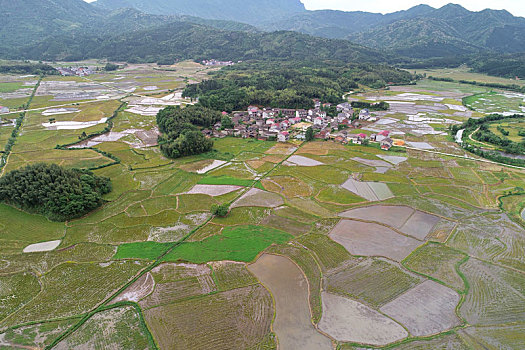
[347, 4, 525, 58]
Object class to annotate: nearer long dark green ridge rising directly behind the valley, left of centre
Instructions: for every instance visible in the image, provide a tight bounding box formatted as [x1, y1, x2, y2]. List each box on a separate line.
[19, 21, 394, 63]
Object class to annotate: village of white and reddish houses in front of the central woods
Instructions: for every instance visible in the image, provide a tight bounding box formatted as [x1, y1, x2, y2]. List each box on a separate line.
[203, 100, 393, 150]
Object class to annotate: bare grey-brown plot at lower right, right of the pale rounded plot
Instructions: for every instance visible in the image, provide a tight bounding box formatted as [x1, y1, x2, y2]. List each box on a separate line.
[380, 281, 461, 336]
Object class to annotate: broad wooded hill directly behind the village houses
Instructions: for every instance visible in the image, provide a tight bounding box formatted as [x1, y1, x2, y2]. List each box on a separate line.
[184, 61, 413, 111]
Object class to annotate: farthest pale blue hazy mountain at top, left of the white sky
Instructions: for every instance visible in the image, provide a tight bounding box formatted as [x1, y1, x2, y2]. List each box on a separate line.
[94, 0, 305, 23]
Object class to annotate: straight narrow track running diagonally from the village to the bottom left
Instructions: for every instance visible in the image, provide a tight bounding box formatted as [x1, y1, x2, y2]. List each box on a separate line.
[45, 144, 303, 350]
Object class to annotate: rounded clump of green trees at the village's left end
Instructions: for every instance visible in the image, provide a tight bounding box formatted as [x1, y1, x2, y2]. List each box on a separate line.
[157, 106, 221, 158]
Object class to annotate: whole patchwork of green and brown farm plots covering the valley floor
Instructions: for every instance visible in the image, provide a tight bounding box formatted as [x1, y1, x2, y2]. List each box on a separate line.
[0, 67, 525, 350]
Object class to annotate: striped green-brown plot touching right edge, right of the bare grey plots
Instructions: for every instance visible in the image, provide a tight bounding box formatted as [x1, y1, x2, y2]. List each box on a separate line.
[460, 259, 525, 325]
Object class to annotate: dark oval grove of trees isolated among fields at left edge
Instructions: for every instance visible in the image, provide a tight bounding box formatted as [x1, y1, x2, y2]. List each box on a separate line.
[0, 163, 111, 221]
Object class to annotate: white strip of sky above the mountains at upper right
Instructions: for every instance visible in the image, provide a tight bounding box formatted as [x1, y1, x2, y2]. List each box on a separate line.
[301, 0, 525, 17]
